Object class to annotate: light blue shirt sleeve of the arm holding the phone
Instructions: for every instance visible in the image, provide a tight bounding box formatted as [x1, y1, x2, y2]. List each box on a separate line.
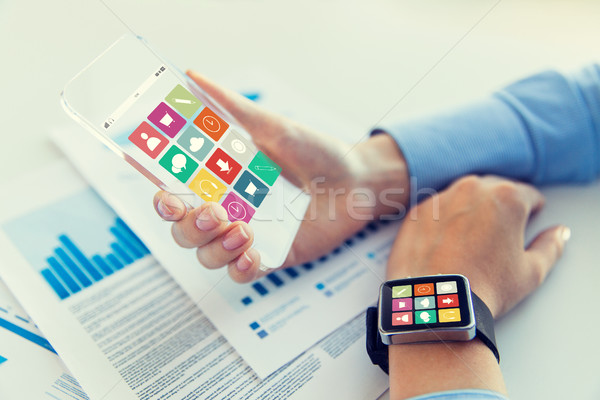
[383, 65, 600, 189]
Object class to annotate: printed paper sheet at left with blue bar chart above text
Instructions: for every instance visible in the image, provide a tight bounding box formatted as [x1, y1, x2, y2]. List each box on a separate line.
[0, 163, 387, 400]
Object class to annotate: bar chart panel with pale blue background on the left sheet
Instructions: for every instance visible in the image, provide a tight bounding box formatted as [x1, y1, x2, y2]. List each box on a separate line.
[3, 189, 150, 300]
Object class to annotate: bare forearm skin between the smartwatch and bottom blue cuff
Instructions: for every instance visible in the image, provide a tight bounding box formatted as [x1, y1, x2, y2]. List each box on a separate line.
[389, 339, 506, 400]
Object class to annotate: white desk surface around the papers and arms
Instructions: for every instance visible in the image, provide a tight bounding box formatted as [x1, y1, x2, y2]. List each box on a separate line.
[0, 0, 600, 399]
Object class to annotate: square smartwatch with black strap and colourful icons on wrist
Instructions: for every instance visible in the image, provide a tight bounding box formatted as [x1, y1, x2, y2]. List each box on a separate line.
[367, 275, 500, 373]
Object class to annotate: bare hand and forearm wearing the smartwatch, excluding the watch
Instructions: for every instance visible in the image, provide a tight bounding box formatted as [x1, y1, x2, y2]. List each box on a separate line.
[387, 176, 570, 399]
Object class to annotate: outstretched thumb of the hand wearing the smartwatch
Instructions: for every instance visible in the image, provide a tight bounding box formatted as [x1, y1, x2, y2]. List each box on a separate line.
[525, 225, 571, 290]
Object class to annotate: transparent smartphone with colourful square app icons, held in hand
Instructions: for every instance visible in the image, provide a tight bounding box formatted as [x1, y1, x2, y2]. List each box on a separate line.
[62, 35, 310, 269]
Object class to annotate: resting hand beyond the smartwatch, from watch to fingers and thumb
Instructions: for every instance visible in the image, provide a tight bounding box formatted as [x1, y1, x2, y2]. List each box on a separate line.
[388, 176, 570, 318]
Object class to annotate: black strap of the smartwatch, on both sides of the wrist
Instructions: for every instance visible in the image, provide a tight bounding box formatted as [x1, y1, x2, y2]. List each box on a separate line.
[366, 292, 500, 374]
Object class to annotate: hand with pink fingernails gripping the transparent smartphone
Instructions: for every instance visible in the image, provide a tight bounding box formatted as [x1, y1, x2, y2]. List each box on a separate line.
[154, 72, 408, 282]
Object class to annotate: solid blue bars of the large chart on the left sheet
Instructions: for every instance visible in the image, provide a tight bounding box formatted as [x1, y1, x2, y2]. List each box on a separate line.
[41, 218, 150, 300]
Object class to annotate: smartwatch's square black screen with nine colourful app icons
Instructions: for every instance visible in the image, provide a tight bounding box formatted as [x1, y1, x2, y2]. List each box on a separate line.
[379, 275, 473, 334]
